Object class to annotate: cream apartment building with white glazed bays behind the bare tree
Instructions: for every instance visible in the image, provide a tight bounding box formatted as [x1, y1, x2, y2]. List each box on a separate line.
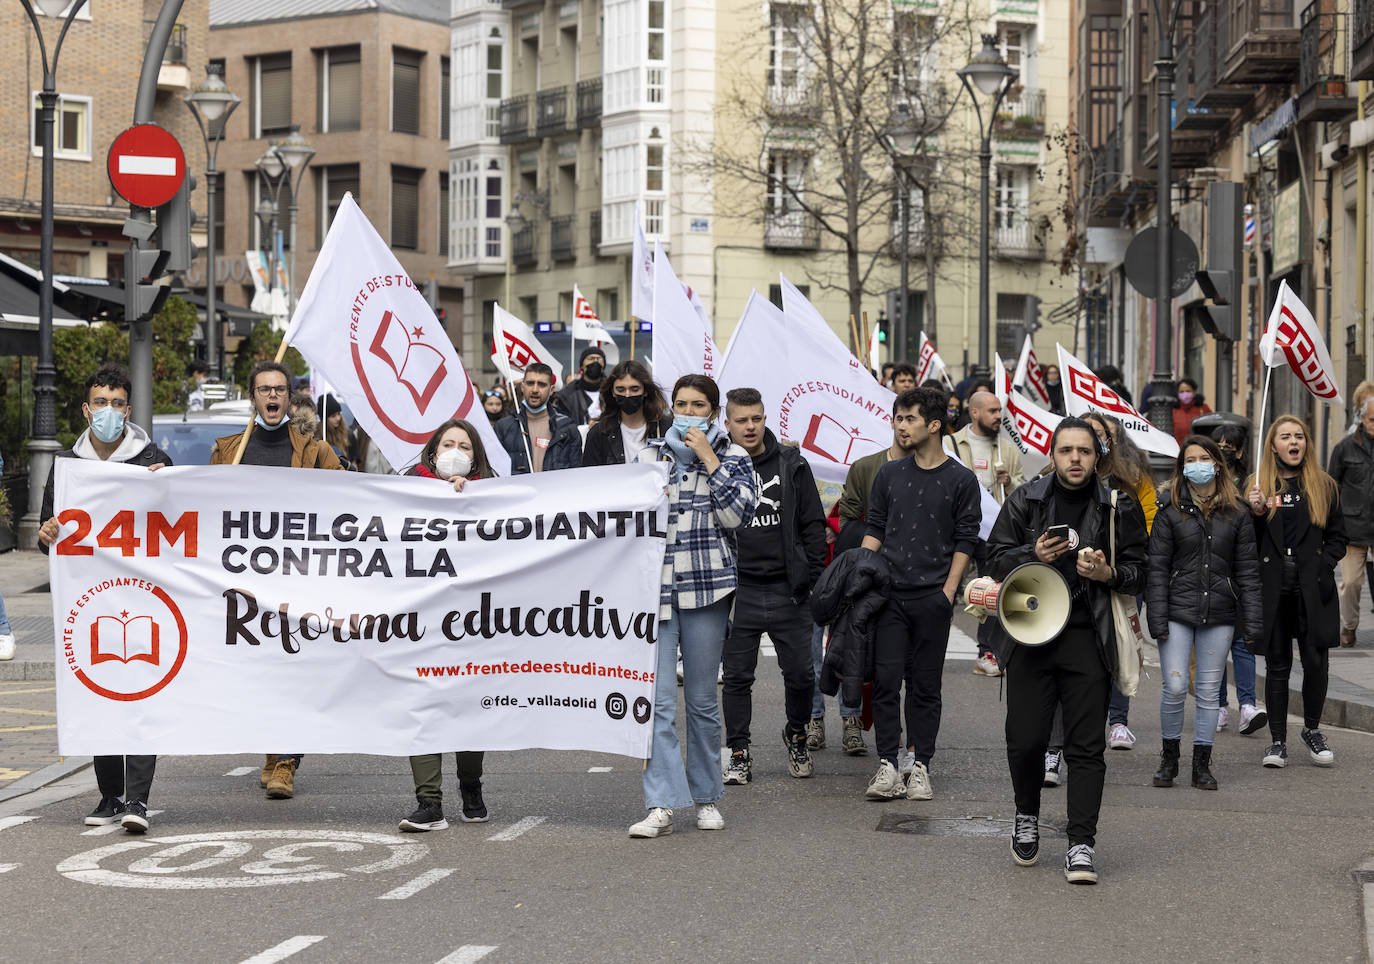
[448, 0, 1073, 379]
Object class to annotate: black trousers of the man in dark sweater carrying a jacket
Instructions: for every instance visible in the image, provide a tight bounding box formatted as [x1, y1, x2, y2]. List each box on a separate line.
[872, 588, 954, 766]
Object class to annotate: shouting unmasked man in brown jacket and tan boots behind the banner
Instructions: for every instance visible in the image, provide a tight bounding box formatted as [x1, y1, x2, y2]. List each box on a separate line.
[210, 361, 344, 801]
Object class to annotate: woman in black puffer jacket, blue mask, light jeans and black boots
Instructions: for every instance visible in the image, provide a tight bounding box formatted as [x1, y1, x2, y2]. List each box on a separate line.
[1145, 435, 1263, 790]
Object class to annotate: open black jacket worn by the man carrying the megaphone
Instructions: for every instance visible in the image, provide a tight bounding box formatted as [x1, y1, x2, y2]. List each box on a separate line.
[988, 472, 1150, 674]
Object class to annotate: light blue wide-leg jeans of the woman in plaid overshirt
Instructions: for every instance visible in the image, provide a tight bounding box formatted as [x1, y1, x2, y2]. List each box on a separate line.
[643, 596, 731, 810]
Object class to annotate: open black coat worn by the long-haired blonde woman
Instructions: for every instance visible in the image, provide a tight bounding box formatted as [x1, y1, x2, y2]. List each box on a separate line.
[1250, 483, 1345, 654]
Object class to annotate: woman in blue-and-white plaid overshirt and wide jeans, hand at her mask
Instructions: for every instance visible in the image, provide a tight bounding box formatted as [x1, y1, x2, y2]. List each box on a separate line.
[629, 374, 757, 838]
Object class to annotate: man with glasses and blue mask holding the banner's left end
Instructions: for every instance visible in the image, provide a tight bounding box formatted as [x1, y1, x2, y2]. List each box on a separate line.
[38, 365, 172, 834]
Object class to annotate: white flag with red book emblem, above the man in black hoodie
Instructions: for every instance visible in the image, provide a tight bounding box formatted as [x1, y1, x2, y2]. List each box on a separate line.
[719, 288, 894, 485]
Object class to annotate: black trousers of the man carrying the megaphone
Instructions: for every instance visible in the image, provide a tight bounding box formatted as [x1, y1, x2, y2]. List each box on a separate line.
[1006, 626, 1112, 846]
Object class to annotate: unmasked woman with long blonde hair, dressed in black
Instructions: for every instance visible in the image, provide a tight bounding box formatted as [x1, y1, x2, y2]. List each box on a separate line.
[1246, 415, 1345, 768]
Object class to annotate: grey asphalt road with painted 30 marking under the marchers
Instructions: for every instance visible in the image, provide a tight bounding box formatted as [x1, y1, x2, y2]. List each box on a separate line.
[0, 634, 1374, 964]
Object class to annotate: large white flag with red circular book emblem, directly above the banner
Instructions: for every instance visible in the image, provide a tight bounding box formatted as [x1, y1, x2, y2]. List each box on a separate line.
[286, 194, 510, 475]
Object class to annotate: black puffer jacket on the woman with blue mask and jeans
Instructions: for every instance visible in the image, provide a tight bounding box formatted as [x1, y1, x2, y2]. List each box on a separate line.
[1145, 486, 1264, 640]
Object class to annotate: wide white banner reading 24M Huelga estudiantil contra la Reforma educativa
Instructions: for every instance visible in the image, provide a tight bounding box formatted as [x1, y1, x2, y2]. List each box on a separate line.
[49, 459, 668, 758]
